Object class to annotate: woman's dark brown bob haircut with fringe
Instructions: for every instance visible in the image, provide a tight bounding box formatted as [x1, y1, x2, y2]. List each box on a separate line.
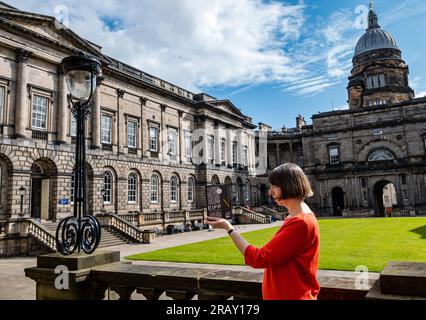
[269, 163, 314, 200]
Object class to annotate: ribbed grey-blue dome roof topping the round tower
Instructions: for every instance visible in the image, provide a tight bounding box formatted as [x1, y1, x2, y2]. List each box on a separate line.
[354, 8, 399, 57]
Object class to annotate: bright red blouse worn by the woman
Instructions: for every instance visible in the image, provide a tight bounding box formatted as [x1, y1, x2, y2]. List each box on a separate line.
[244, 213, 320, 300]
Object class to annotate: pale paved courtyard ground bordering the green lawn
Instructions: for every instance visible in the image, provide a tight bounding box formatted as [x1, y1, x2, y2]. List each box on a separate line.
[0, 222, 378, 300]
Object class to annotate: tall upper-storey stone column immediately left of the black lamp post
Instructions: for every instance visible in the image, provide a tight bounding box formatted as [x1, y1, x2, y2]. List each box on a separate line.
[56, 70, 71, 144]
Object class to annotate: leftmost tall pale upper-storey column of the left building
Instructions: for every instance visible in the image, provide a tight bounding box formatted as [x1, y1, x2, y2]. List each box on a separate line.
[15, 49, 32, 138]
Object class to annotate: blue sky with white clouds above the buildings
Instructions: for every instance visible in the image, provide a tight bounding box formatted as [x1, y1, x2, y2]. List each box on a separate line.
[9, 0, 426, 129]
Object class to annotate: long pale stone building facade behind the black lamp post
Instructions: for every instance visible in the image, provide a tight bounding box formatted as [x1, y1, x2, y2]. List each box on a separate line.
[0, 5, 259, 228]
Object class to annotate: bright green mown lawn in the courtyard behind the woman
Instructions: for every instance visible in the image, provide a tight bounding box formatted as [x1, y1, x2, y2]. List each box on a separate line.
[126, 217, 426, 272]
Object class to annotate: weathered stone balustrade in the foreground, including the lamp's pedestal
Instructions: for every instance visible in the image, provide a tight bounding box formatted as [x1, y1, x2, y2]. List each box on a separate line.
[25, 250, 426, 300]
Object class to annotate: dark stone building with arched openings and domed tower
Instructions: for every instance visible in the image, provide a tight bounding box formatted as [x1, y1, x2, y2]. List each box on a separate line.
[263, 5, 426, 216]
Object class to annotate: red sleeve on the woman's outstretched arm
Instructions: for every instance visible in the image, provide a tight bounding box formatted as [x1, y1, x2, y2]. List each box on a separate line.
[244, 219, 308, 269]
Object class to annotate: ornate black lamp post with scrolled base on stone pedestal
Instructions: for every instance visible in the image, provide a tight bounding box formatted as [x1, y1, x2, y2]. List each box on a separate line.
[56, 52, 101, 255]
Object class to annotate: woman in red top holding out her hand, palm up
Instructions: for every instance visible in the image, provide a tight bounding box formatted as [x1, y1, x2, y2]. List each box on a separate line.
[207, 163, 320, 300]
